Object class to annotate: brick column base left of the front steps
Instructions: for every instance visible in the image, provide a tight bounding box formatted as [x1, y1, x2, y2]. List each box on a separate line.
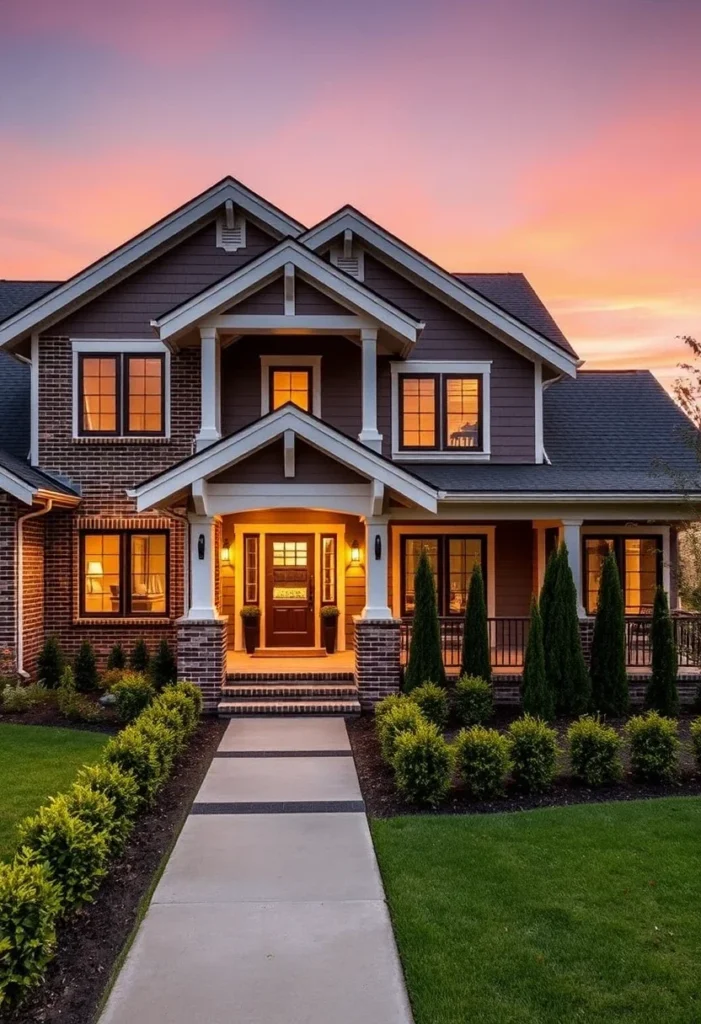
[177, 616, 228, 712]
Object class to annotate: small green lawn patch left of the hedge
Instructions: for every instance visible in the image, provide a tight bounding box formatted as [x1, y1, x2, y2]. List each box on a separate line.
[0, 724, 109, 860]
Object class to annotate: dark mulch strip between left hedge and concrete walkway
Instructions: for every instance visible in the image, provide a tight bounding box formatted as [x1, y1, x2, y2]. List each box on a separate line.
[0, 716, 226, 1024]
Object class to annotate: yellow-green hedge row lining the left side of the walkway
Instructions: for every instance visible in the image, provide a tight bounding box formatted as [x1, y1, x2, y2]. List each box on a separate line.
[0, 683, 202, 1007]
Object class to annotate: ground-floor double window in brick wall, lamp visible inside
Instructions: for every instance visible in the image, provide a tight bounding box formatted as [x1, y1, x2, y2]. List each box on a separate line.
[81, 530, 168, 616]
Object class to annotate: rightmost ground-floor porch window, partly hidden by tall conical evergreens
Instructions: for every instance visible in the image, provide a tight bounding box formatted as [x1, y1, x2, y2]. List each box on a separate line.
[584, 536, 662, 615]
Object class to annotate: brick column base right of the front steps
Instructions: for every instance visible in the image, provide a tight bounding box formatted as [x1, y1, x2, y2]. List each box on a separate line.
[353, 615, 401, 711]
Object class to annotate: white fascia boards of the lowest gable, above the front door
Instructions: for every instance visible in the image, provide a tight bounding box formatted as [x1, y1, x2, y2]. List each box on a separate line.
[127, 406, 438, 512]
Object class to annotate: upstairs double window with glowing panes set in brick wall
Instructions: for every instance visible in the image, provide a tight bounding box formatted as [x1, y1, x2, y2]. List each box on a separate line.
[78, 353, 166, 436]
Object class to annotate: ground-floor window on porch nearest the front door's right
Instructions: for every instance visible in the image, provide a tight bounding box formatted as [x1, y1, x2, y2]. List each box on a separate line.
[401, 536, 486, 615]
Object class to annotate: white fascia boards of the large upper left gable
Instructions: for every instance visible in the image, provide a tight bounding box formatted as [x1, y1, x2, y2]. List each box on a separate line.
[0, 178, 304, 348]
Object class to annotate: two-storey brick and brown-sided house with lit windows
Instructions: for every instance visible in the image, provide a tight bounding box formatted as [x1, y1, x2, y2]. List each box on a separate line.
[0, 178, 701, 710]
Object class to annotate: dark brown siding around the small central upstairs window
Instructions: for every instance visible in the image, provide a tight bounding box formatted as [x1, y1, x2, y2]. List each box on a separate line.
[221, 337, 362, 437]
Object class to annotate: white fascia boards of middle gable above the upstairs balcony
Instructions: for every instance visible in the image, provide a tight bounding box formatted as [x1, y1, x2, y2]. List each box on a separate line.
[151, 239, 424, 343]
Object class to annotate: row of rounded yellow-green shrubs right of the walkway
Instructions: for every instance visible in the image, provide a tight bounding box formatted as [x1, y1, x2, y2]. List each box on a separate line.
[376, 684, 701, 806]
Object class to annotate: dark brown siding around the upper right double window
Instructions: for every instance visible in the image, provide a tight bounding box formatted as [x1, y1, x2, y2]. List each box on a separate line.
[365, 255, 535, 462]
